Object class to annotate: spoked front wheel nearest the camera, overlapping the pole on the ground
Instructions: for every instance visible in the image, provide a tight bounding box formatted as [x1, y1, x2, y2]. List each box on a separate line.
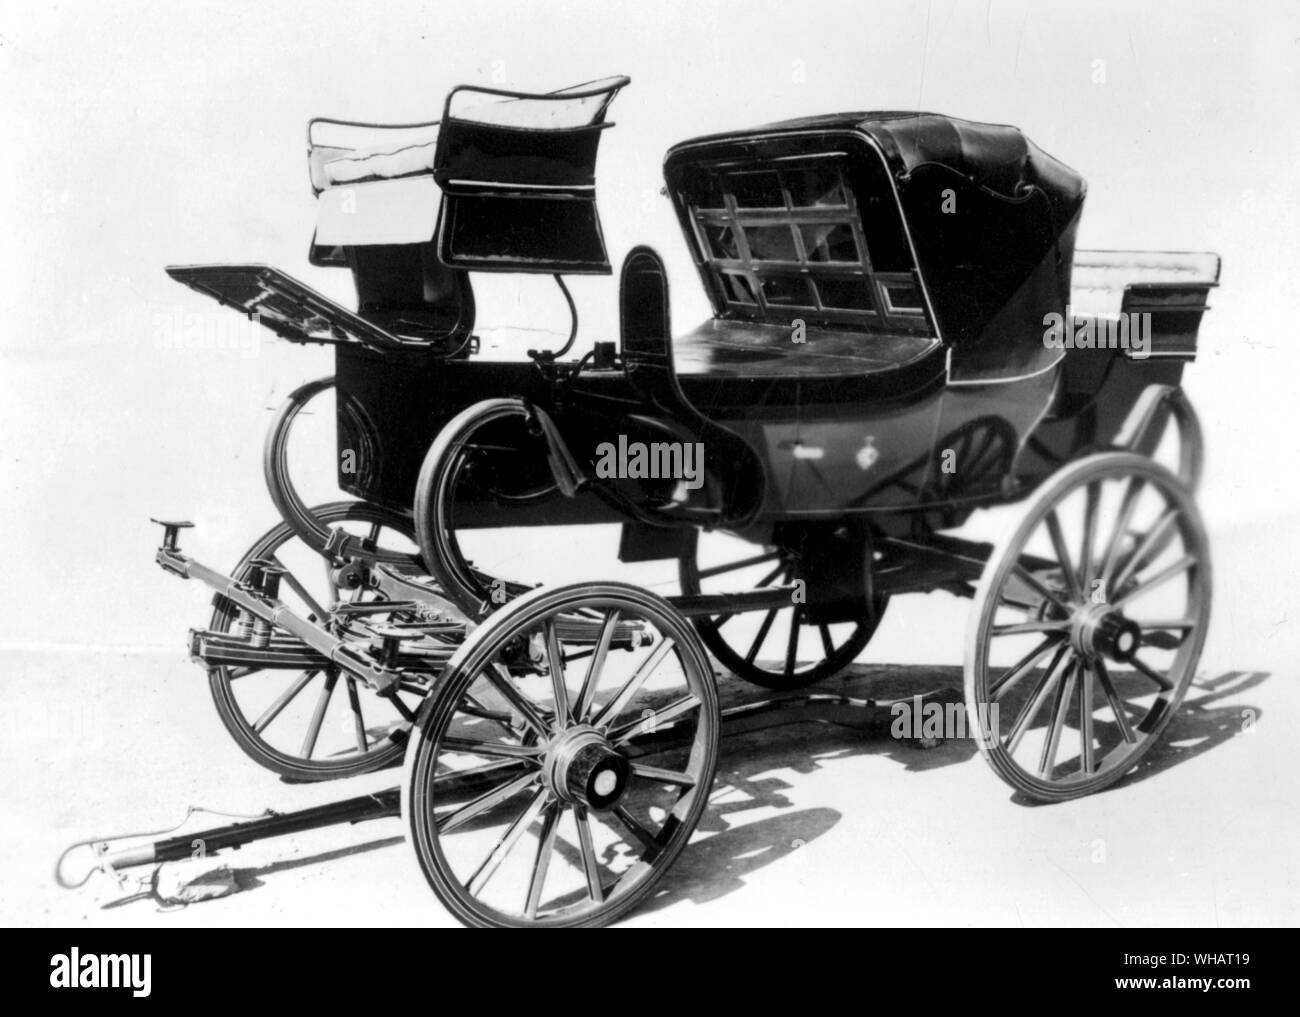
[402, 583, 720, 927]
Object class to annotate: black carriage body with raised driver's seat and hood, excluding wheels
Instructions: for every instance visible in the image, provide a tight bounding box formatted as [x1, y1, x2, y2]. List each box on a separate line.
[169, 87, 1218, 541]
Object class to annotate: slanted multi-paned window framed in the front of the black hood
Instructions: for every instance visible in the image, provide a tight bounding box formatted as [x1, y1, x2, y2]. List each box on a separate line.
[683, 156, 930, 333]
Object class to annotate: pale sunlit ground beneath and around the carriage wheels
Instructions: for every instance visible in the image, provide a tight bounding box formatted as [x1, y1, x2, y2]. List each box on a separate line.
[0, 524, 1300, 927]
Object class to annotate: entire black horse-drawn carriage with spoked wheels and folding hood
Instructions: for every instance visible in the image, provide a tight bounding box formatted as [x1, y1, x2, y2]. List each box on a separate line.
[78, 78, 1218, 925]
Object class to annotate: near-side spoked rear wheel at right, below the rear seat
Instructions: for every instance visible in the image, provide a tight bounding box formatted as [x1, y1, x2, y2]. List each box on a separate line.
[966, 453, 1210, 801]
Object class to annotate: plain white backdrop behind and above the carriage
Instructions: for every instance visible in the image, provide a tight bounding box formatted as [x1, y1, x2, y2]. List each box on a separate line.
[0, 0, 1300, 666]
